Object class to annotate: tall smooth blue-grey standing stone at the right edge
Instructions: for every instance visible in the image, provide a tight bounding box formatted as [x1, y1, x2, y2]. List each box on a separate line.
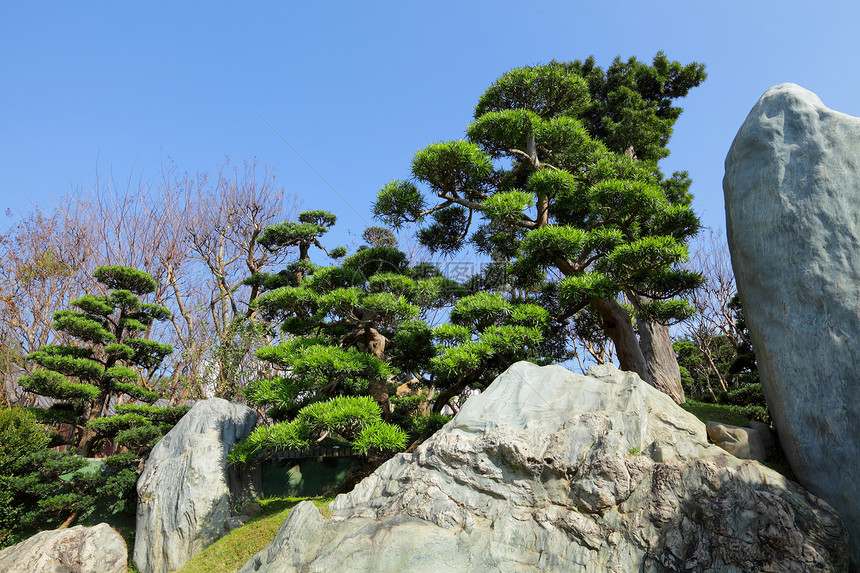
[723, 84, 860, 571]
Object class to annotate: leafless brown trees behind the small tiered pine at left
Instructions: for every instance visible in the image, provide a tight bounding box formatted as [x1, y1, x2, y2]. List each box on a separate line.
[0, 160, 296, 404]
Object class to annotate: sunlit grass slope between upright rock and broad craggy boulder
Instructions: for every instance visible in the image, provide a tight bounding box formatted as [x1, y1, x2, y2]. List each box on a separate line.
[175, 497, 334, 573]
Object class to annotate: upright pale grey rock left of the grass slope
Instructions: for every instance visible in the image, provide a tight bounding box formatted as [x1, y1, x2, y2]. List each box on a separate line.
[134, 398, 257, 573]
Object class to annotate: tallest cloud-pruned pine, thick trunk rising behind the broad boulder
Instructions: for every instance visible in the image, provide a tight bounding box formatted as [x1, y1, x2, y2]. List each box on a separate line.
[374, 54, 705, 401]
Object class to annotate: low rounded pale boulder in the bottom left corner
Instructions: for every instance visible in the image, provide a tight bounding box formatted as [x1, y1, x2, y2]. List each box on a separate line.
[0, 523, 128, 573]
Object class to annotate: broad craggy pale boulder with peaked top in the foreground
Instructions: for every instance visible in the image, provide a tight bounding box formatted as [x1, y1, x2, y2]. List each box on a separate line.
[241, 362, 848, 573]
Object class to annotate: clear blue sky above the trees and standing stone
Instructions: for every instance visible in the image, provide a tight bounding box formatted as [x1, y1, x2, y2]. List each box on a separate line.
[0, 0, 860, 250]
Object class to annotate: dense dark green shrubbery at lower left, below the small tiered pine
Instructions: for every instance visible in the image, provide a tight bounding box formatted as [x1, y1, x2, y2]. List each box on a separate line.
[0, 404, 188, 547]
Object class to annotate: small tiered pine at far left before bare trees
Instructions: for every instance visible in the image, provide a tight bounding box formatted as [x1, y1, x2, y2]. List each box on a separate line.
[20, 266, 172, 456]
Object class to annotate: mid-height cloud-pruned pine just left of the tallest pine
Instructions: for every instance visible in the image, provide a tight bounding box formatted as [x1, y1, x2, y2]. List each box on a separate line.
[233, 212, 480, 463]
